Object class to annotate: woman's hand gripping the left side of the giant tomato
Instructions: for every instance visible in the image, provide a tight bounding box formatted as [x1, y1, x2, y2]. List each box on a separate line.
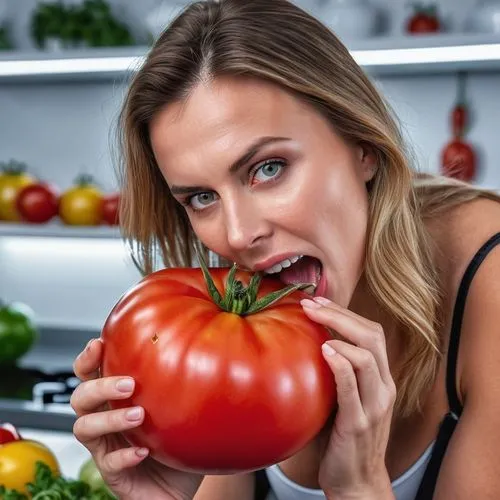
[71, 339, 203, 500]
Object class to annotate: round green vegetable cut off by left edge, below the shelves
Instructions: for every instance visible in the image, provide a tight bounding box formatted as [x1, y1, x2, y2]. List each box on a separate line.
[0, 301, 38, 365]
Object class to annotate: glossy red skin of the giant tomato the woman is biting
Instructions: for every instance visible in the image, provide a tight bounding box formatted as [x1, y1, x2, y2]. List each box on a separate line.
[102, 268, 336, 474]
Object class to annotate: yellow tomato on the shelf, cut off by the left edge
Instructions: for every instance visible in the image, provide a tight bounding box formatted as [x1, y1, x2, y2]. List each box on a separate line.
[0, 160, 36, 222]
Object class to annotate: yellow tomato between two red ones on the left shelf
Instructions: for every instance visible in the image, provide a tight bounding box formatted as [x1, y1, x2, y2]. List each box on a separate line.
[59, 179, 104, 226]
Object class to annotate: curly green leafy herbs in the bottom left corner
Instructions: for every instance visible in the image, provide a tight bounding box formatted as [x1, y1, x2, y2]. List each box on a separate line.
[0, 461, 115, 500]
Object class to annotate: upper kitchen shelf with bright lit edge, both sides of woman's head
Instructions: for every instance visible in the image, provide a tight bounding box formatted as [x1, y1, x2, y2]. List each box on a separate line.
[0, 34, 500, 84]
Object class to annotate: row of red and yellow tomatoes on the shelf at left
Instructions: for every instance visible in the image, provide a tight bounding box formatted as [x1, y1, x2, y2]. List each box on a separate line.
[0, 161, 120, 226]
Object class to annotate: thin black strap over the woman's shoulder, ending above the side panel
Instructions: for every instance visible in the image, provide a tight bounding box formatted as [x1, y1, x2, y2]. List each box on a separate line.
[446, 233, 500, 417]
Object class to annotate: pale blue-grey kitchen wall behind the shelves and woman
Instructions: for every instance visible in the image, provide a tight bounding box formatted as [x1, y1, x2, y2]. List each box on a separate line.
[0, 0, 500, 336]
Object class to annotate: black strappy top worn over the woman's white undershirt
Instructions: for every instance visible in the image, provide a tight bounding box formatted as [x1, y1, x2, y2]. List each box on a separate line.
[255, 233, 500, 500]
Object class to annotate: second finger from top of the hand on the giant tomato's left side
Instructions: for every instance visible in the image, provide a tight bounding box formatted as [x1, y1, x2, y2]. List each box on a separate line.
[70, 377, 135, 416]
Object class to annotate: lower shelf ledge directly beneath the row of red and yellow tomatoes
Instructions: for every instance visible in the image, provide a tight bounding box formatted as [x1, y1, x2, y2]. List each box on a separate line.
[0, 222, 121, 239]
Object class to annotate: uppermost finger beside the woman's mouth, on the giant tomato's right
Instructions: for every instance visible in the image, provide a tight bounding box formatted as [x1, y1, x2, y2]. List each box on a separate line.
[301, 299, 392, 385]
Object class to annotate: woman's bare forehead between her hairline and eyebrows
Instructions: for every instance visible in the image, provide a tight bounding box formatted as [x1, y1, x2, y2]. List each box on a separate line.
[150, 78, 312, 177]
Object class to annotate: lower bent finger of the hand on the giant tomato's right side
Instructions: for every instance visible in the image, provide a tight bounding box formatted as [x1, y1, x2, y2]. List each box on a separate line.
[327, 340, 384, 415]
